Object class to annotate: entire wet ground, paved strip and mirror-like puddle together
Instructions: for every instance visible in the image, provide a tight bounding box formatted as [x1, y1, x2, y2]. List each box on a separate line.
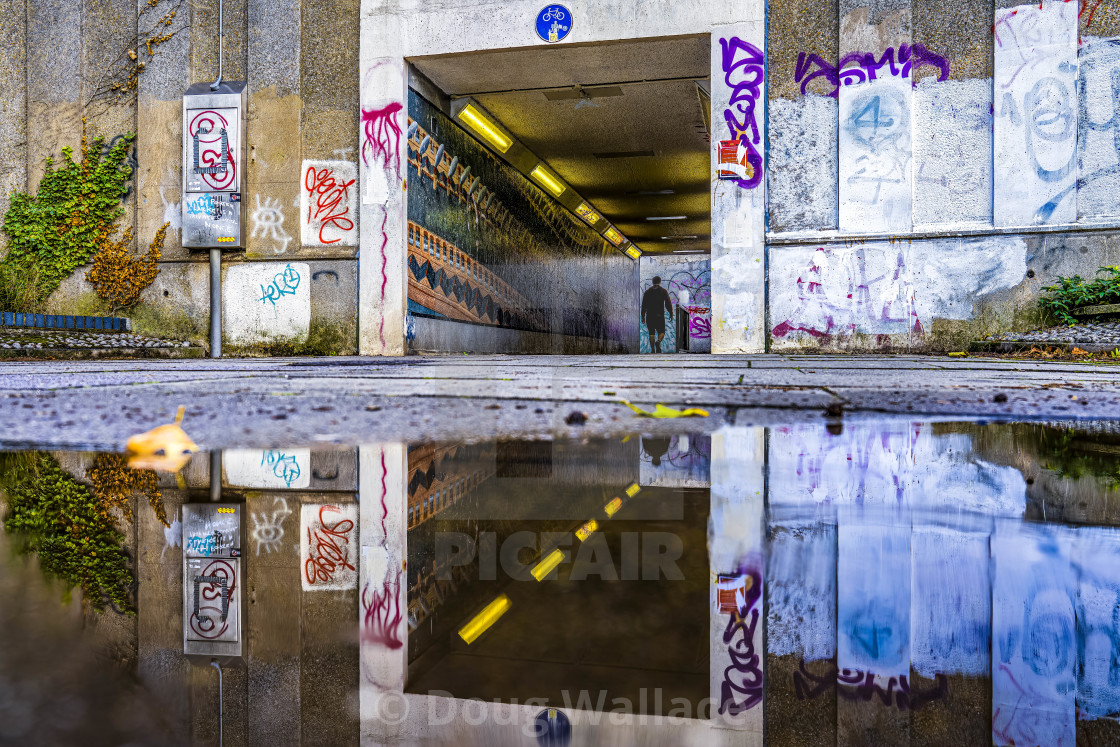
[0, 356, 1120, 747]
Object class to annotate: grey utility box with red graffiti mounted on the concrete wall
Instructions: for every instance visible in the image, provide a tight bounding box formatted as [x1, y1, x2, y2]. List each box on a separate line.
[183, 83, 245, 249]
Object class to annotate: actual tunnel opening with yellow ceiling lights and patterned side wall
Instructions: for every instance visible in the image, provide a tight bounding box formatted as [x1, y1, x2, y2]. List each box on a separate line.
[407, 35, 711, 353]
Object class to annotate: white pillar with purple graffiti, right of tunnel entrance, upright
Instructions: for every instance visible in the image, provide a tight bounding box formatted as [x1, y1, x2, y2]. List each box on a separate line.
[711, 16, 766, 353]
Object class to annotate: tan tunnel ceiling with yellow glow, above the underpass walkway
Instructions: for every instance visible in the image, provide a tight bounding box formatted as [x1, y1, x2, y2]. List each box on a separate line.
[410, 36, 711, 253]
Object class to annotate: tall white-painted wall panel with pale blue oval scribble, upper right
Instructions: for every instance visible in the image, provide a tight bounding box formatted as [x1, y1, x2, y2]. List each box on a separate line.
[992, 0, 1077, 226]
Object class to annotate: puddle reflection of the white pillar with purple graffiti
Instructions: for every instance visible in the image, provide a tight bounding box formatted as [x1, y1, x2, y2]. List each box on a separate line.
[708, 428, 766, 741]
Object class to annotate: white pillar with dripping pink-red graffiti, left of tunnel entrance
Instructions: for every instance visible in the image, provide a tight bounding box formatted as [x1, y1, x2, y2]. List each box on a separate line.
[358, 5, 408, 355]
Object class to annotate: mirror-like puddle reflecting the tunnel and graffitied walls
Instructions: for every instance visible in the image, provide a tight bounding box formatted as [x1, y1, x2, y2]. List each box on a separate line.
[0, 420, 1120, 745]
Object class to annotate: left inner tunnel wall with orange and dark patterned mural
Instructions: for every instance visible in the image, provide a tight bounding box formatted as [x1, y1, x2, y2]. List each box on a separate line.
[407, 91, 637, 352]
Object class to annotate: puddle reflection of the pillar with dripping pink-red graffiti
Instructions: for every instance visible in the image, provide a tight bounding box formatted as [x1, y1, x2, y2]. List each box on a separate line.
[358, 443, 407, 744]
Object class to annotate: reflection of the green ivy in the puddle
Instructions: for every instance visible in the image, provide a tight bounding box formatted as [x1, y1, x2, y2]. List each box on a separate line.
[0, 452, 136, 615]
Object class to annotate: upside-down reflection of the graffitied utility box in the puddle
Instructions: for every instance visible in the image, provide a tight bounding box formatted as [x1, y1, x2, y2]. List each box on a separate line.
[183, 503, 242, 656]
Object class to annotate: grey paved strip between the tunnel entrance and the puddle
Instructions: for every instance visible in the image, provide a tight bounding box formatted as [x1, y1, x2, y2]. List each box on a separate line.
[0, 355, 1120, 449]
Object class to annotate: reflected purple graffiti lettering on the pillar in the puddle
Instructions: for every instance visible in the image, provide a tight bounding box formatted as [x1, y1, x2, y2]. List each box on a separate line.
[719, 570, 763, 716]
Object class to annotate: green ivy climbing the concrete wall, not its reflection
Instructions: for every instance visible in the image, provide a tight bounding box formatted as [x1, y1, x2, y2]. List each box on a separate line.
[3, 123, 136, 302]
